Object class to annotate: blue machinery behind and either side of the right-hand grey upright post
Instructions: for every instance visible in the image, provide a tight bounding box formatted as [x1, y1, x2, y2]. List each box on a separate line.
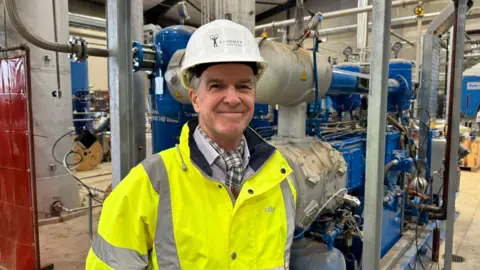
[307, 59, 431, 269]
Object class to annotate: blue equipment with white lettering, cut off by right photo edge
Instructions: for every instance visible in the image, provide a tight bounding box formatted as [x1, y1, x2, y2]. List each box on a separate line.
[460, 76, 480, 117]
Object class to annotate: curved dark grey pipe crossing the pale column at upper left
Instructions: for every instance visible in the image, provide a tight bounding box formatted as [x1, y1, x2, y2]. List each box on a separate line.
[4, 0, 108, 57]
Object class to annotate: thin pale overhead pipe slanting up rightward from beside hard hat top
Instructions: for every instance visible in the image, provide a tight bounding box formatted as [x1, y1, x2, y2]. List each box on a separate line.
[255, 0, 436, 31]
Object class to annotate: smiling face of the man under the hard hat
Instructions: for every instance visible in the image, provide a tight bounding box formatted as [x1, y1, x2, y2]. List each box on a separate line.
[189, 64, 255, 139]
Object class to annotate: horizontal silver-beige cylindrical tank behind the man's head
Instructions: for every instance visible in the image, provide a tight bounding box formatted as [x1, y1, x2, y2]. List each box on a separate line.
[165, 39, 332, 106]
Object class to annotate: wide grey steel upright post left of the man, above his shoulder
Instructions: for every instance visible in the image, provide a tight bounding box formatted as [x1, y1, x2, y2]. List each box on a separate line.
[107, 0, 146, 187]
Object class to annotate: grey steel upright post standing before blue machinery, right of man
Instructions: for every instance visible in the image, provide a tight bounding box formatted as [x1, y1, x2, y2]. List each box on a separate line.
[362, 0, 390, 269]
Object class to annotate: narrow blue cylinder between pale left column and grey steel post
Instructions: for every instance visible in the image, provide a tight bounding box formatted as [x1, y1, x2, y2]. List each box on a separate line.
[70, 60, 92, 135]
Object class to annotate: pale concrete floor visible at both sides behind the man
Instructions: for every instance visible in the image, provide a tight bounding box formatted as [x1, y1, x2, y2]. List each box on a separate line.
[39, 166, 480, 270]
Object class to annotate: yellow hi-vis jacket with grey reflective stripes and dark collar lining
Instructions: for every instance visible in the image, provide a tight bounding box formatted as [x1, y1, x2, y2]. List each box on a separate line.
[86, 120, 296, 270]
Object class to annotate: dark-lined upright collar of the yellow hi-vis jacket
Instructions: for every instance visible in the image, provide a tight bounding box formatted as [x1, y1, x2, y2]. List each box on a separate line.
[180, 118, 276, 177]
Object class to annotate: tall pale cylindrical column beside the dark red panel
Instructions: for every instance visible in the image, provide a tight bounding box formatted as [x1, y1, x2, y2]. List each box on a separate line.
[0, 0, 80, 213]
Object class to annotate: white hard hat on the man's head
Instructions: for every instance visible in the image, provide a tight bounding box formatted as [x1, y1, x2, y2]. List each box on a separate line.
[180, 20, 267, 88]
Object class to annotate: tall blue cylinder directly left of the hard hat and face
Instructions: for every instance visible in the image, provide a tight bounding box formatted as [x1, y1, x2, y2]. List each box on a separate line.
[150, 25, 195, 153]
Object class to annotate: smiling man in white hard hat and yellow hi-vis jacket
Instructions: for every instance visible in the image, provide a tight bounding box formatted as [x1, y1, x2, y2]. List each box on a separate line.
[86, 20, 296, 269]
